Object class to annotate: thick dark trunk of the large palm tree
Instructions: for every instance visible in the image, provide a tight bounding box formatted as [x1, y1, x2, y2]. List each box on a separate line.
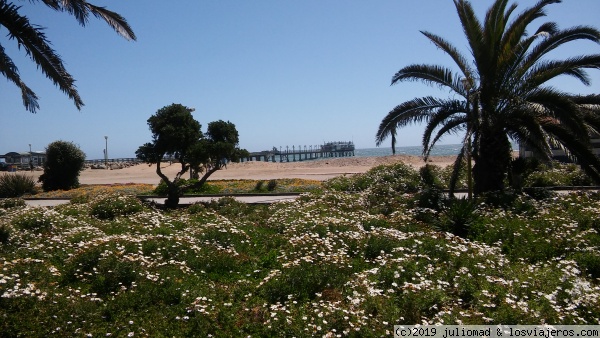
[473, 127, 512, 195]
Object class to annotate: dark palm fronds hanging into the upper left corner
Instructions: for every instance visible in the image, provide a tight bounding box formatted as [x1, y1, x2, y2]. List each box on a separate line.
[0, 0, 136, 113]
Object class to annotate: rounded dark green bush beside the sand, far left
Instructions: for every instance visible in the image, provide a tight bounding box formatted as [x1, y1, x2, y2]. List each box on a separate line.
[40, 141, 85, 191]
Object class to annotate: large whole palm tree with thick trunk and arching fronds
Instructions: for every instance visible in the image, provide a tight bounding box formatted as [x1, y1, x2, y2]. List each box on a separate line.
[376, 0, 600, 194]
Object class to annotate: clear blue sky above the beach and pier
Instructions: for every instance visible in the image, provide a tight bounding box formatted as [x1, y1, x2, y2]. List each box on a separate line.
[0, 0, 600, 159]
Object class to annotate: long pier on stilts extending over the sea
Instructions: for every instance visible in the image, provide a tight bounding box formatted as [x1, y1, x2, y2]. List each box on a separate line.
[242, 142, 354, 162]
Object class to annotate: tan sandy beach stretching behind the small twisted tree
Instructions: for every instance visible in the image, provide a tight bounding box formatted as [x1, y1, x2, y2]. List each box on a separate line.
[16, 155, 456, 184]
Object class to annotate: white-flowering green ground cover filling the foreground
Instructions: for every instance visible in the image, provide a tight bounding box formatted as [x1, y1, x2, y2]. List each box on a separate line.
[0, 165, 600, 337]
